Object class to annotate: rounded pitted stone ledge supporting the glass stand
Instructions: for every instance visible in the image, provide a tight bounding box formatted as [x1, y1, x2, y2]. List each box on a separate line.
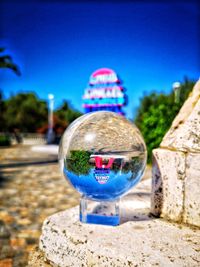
[37, 204, 200, 267]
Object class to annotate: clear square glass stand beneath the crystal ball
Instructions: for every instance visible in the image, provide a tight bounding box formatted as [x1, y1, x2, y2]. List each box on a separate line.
[80, 196, 120, 226]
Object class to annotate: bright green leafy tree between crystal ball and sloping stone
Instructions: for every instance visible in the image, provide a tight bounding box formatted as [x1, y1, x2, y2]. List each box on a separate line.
[135, 77, 195, 162]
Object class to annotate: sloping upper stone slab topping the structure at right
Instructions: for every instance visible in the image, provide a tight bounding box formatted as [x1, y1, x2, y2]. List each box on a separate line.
[160, 80, 200, 152]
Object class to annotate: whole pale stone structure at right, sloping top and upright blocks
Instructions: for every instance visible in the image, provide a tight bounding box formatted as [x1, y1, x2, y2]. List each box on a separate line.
[151, 80, 200, 226]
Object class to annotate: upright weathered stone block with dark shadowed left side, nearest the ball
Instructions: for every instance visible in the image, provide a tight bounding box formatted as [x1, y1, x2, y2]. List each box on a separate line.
[151, 149, 185, 221]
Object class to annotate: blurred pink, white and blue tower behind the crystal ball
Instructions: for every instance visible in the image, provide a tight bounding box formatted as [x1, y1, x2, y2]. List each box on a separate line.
[83, 68, 127, 115]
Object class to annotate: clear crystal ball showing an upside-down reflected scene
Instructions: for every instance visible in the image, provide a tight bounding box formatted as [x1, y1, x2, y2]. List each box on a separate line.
[59, 111, 147, 201]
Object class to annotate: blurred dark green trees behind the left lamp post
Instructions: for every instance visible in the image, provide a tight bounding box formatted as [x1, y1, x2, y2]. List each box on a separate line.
[0, 91, 82, 136]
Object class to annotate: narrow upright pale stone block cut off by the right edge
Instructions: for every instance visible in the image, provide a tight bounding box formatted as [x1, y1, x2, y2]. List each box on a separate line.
[184, 153, 200, 227]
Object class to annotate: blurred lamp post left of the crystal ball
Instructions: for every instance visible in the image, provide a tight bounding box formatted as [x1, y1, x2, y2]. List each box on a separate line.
[47, 94, 55, 144]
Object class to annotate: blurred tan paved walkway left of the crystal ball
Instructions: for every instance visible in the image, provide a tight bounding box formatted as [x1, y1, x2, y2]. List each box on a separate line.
[0, 145, 150, 267]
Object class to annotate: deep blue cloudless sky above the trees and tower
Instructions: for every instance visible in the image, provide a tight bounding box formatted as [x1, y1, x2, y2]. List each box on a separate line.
[0, 0, 200, 118]
